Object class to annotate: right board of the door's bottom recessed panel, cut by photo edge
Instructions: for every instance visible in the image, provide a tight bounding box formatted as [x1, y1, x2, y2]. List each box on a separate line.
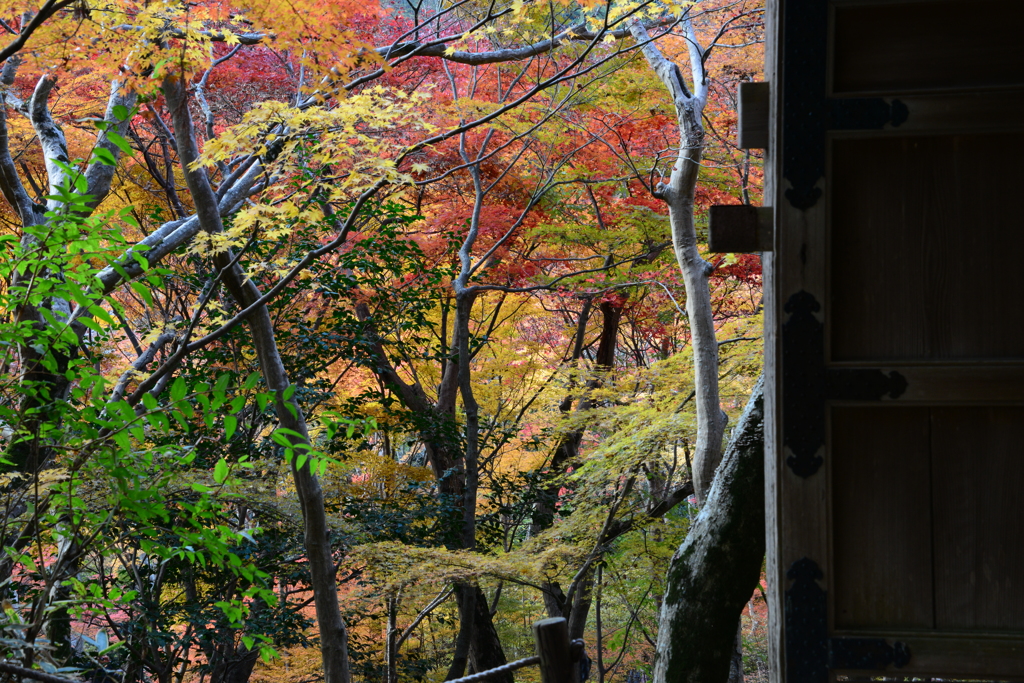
[932, 408, 1024, 634]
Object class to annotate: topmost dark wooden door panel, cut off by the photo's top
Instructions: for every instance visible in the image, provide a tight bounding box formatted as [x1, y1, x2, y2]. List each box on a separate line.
[833, 0, 1024, 93]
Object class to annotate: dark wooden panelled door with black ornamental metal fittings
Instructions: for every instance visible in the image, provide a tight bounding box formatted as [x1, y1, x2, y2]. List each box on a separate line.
[765, 0, 1024, 683]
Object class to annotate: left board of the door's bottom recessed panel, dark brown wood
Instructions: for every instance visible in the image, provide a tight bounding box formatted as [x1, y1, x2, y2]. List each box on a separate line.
[829, 405, 934, 629]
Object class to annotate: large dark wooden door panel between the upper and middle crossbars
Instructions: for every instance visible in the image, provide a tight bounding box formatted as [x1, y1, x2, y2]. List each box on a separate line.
[829, 135, 1024, 361]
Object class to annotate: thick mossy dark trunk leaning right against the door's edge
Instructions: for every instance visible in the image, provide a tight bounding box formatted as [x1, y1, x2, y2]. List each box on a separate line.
[654, 377, 765, 683]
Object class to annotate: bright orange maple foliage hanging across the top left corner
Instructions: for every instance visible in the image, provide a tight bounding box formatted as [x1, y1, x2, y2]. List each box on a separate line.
[0, 0, 379, 91]
